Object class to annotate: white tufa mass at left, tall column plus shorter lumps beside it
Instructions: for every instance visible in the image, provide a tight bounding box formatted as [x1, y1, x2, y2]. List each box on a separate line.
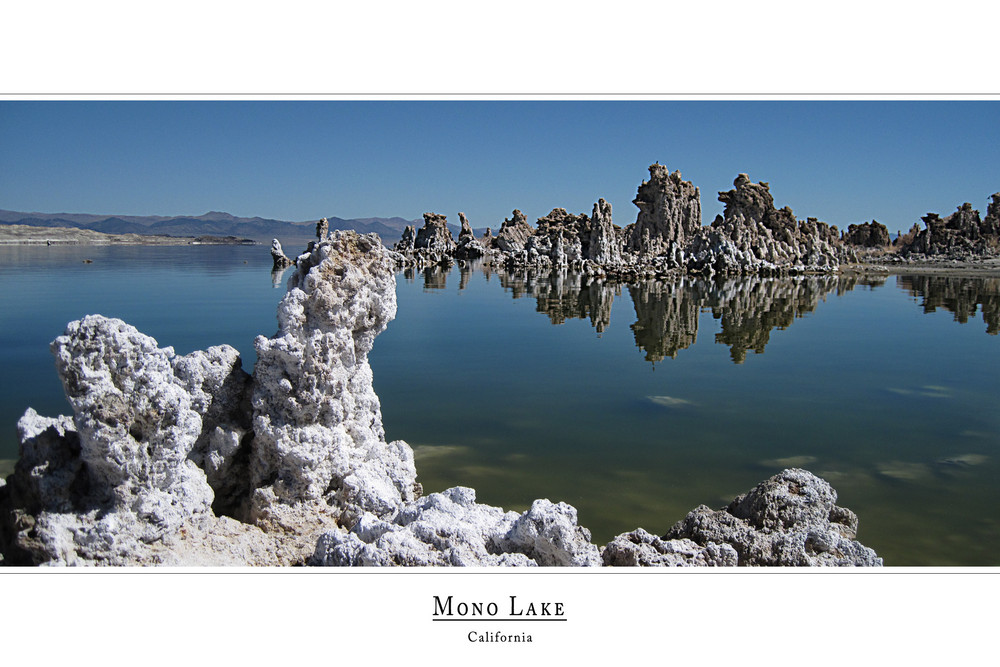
[0, 232, 419, 565]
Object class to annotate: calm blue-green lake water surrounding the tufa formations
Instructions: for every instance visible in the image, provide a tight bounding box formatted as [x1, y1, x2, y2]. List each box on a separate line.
[0, 246, 1000, 565]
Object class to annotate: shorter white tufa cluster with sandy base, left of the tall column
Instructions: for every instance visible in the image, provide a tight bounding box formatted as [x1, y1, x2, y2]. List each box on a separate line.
[0, 315, 290, 565]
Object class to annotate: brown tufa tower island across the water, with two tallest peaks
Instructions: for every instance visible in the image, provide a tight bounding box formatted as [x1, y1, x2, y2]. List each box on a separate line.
[396, 163, 881, 280]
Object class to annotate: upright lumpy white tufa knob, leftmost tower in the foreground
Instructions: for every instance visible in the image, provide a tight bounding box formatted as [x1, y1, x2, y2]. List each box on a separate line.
[52, 315, 212, 520]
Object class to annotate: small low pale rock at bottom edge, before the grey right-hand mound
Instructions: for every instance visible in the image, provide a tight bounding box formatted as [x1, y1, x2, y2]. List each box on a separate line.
[601, 528, 739, 567]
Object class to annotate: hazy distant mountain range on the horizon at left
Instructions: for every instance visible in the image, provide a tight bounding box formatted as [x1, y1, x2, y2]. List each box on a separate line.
[0, 209, 483, 247]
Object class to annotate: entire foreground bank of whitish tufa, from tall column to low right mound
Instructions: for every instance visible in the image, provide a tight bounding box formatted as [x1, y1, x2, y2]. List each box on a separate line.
[0, 232, 877, 566]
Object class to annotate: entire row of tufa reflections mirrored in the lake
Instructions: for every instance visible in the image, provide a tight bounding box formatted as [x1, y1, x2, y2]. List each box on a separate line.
[476, 266, 1000, 364]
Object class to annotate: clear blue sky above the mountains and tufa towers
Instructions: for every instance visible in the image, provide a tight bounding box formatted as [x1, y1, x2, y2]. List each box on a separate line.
[0, 100, 1000, 231]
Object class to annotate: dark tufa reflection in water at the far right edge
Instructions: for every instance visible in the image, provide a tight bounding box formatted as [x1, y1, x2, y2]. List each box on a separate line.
[896, 276, 1000, 336]
